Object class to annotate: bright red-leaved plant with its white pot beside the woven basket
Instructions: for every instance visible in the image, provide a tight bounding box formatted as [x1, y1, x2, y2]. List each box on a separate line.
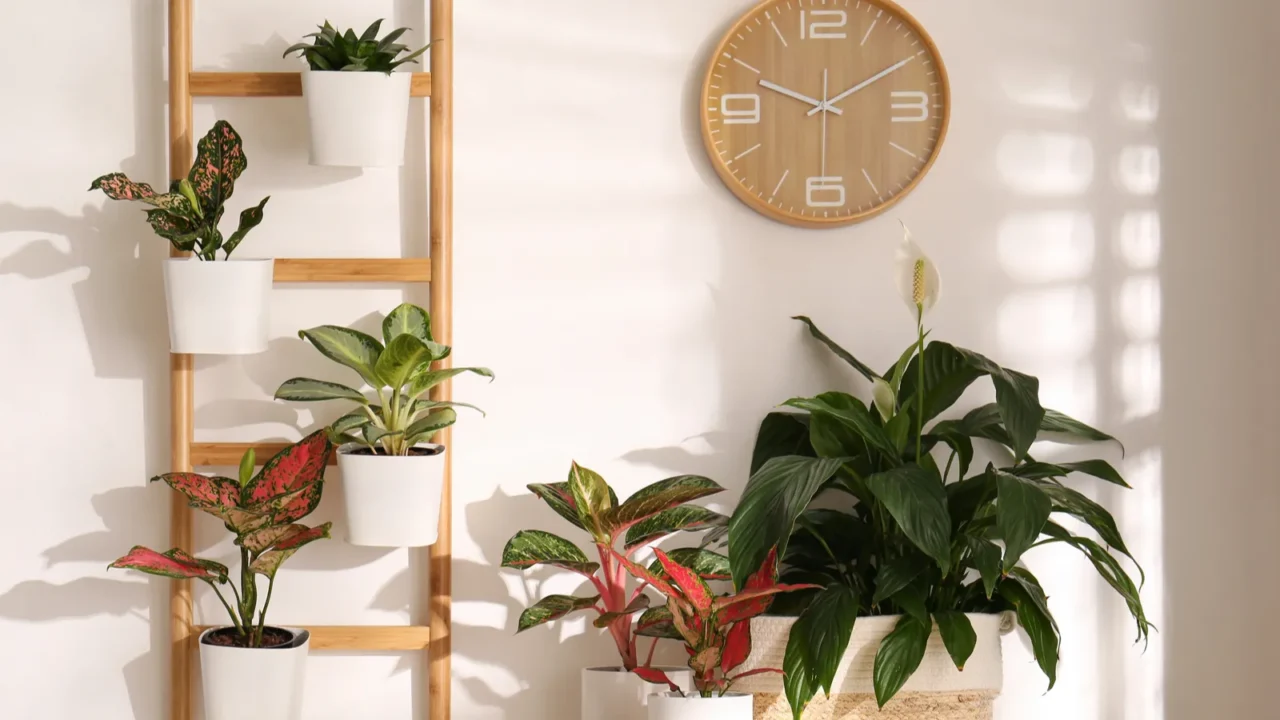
[616, 550, 822, 720]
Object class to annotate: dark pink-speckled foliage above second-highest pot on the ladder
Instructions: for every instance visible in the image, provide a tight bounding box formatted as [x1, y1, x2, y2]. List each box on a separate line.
[90, 120, 270, 260]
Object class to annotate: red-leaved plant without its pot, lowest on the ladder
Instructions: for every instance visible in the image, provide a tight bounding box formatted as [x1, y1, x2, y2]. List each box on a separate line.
[110, 430, 333, 647]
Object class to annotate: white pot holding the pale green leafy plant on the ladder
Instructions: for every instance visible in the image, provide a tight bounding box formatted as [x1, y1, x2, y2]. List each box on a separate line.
[338, 443, 444, 547]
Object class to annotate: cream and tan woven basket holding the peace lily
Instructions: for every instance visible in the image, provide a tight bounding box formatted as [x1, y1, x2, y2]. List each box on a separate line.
[733, 615, 1014, 720]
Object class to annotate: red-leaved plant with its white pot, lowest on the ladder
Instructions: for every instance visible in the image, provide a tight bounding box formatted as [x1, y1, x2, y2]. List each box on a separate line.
[110, 432, 333, 720]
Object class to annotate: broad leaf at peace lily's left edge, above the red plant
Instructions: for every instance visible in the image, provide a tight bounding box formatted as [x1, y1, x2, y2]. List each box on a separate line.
[728, 456, 841, 587]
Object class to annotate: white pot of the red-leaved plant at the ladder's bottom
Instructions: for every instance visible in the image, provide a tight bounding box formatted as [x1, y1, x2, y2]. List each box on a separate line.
[200, 628, 311, 720]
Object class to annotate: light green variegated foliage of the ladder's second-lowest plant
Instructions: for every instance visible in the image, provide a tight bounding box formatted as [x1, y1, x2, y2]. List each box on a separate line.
[275, 304, 493, 455]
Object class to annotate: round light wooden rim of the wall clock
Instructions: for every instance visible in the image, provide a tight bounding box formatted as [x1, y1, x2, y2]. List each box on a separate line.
[699, 0, 951, 228]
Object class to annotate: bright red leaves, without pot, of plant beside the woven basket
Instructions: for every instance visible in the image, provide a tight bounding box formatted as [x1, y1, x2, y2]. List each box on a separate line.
[617, 550, 822, 697]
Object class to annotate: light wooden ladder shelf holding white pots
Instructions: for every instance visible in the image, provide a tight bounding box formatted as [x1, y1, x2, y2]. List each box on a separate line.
[169, 0, 453, 720]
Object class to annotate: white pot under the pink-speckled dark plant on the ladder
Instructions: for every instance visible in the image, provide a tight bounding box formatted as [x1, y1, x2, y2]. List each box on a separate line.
[164, 258, 275, 355]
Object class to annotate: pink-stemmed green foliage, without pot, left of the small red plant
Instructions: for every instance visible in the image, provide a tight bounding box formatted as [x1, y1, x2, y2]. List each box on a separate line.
[502, 462, 730, 682]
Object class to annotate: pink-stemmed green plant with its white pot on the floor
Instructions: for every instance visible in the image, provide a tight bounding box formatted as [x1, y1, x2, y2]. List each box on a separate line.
[502, 462, 730, 720]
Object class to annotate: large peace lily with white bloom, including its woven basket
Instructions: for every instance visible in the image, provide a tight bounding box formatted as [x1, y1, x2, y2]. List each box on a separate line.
[728, 222, 1151, 720]
